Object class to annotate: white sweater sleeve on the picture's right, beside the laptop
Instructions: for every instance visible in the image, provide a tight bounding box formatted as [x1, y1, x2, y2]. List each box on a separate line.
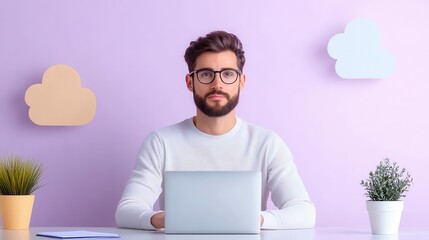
[261, 135, 316, 229]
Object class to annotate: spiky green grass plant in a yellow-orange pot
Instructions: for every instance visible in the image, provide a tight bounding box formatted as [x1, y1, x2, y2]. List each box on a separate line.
[0, 155, 42, 230]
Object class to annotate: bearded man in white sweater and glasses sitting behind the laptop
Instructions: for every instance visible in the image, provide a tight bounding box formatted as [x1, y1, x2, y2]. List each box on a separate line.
[116, 31, 316, 229]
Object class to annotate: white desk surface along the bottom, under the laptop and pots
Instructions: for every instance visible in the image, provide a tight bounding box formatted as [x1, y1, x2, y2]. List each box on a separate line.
[0, 227, 429, 240]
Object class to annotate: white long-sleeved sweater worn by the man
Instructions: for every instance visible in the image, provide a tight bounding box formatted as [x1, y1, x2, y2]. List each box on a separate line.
[115, 118, 316, 229]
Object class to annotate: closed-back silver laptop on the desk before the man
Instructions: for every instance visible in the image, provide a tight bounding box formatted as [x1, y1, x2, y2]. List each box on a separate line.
[164, 171, 261, 234]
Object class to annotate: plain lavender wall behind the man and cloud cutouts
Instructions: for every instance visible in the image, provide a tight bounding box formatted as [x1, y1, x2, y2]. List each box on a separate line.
[0, 0, 429, 227]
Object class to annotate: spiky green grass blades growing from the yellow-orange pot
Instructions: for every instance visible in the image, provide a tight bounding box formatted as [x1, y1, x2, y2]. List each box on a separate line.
[0, 155, 43, 195]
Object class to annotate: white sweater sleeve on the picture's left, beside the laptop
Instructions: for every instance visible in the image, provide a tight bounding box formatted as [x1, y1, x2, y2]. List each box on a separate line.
[115, 133, 164, 230]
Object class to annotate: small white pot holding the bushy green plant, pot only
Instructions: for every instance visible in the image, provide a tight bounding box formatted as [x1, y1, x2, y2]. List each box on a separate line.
[366, 201, 404, 234]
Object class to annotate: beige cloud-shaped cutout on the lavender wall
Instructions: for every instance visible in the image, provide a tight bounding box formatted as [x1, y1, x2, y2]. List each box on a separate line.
[25, 64, 96, 126]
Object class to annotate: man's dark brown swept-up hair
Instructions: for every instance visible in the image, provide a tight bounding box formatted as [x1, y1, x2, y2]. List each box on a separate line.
[185, 31, 246, 72]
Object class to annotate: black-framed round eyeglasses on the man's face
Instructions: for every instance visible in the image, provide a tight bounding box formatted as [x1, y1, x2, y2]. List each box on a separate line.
[189, 68, 241, 84]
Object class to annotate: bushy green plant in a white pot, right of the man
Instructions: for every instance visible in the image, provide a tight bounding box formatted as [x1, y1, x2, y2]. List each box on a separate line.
[360, 158, 413, 234]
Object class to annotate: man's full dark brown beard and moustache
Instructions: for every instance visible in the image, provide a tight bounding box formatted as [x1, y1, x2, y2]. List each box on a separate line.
[193, 89, 240, 117]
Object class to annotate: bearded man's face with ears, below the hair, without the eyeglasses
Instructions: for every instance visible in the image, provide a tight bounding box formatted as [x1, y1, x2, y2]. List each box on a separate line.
[186, 50, 245, 117]
